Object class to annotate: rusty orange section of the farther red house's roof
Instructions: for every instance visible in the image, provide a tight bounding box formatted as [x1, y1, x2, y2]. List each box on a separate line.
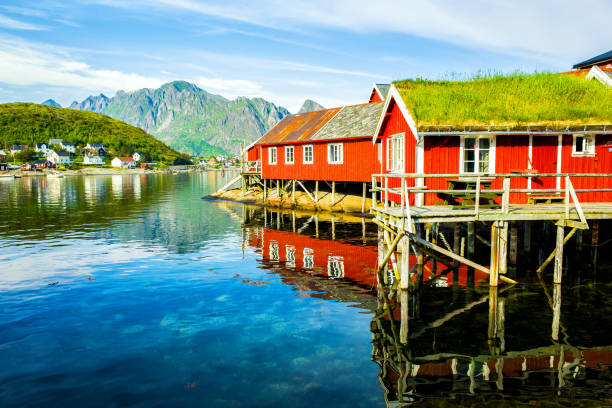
[257, 108, 341, 145]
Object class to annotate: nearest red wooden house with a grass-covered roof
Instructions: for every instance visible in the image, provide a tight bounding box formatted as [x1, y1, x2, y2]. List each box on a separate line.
[373, 74, 612, 205]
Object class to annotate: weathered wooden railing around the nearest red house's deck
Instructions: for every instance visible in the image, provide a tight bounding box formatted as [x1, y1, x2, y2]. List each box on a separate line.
[371, 173, 612, 220]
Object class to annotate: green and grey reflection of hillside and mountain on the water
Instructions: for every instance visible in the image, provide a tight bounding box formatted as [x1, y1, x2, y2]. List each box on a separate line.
[0, 172, 244, 252]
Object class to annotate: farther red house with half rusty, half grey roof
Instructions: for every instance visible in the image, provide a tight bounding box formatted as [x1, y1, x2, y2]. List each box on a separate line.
[247, 102, 383, 182]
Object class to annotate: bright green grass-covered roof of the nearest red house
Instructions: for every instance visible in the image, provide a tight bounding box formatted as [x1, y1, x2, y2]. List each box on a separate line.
[394, 73, 612, 130]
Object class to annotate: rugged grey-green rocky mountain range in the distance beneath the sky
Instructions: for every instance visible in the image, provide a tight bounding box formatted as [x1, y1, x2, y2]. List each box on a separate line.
[69, 81, 296, 156]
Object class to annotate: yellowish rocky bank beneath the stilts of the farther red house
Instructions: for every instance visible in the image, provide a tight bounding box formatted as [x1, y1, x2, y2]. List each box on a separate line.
[207, 189, 372, 217]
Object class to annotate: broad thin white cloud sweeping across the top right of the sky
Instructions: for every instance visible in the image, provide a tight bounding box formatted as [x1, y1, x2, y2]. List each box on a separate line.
[97, 0, 612, 61]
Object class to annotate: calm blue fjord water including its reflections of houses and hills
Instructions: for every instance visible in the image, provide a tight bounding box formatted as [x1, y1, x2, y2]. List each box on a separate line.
[0, 172, 612, 407]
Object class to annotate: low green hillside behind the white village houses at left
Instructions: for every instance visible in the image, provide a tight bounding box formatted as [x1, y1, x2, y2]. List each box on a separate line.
[0, 102, 184, 162]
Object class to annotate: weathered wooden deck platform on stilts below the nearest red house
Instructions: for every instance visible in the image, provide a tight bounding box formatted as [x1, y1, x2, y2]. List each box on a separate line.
[371, 203, 612, 224]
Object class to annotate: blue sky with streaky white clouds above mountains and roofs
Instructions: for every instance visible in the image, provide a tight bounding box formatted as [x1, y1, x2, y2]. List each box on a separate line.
[0, 0, 612, 112]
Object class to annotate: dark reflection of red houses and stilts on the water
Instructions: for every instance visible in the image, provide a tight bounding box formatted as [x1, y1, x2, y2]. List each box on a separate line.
[227, 206, 612, 407]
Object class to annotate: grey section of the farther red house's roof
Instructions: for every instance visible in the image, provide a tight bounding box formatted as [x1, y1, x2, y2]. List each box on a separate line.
[310, 102, 383, 140]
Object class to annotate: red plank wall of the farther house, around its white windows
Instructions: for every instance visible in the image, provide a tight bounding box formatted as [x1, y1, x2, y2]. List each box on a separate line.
[261, 136, 380, 182]
